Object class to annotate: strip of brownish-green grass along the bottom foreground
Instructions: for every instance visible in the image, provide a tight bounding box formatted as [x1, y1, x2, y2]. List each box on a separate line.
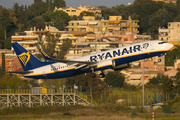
[0, 104, 180, 120]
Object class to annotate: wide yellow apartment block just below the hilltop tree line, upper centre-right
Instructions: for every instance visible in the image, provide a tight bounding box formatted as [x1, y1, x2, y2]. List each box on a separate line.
[66, 16, 139, 36]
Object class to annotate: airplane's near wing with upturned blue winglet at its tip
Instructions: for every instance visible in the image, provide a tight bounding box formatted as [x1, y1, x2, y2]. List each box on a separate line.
[39, 49, 98, 67]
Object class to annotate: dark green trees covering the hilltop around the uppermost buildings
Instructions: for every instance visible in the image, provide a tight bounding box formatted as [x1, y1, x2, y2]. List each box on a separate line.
[0, 0, 180, 47]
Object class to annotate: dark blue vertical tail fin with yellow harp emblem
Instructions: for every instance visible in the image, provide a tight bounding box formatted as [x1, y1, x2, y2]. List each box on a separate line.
[11, 42, 45, 71]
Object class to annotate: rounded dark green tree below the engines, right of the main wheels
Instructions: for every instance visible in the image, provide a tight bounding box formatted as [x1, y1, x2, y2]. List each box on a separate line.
[104, 71, 125, 88]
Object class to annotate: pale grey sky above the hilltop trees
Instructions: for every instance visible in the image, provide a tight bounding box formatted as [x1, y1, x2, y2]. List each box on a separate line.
[0, 0, 134, 8]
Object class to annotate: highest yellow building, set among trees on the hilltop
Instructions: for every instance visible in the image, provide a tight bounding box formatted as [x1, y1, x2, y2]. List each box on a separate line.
[54, 5, 102, 17]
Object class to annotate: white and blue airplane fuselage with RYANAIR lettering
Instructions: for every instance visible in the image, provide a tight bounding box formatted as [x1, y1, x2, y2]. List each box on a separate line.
[24, 40, 173, 78]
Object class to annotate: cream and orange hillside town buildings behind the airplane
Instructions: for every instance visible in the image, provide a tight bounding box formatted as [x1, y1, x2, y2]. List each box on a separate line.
[0, 2, 180, 86]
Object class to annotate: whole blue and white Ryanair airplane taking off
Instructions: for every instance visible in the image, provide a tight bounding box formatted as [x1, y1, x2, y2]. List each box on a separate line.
[10, 40, 174, 79]
